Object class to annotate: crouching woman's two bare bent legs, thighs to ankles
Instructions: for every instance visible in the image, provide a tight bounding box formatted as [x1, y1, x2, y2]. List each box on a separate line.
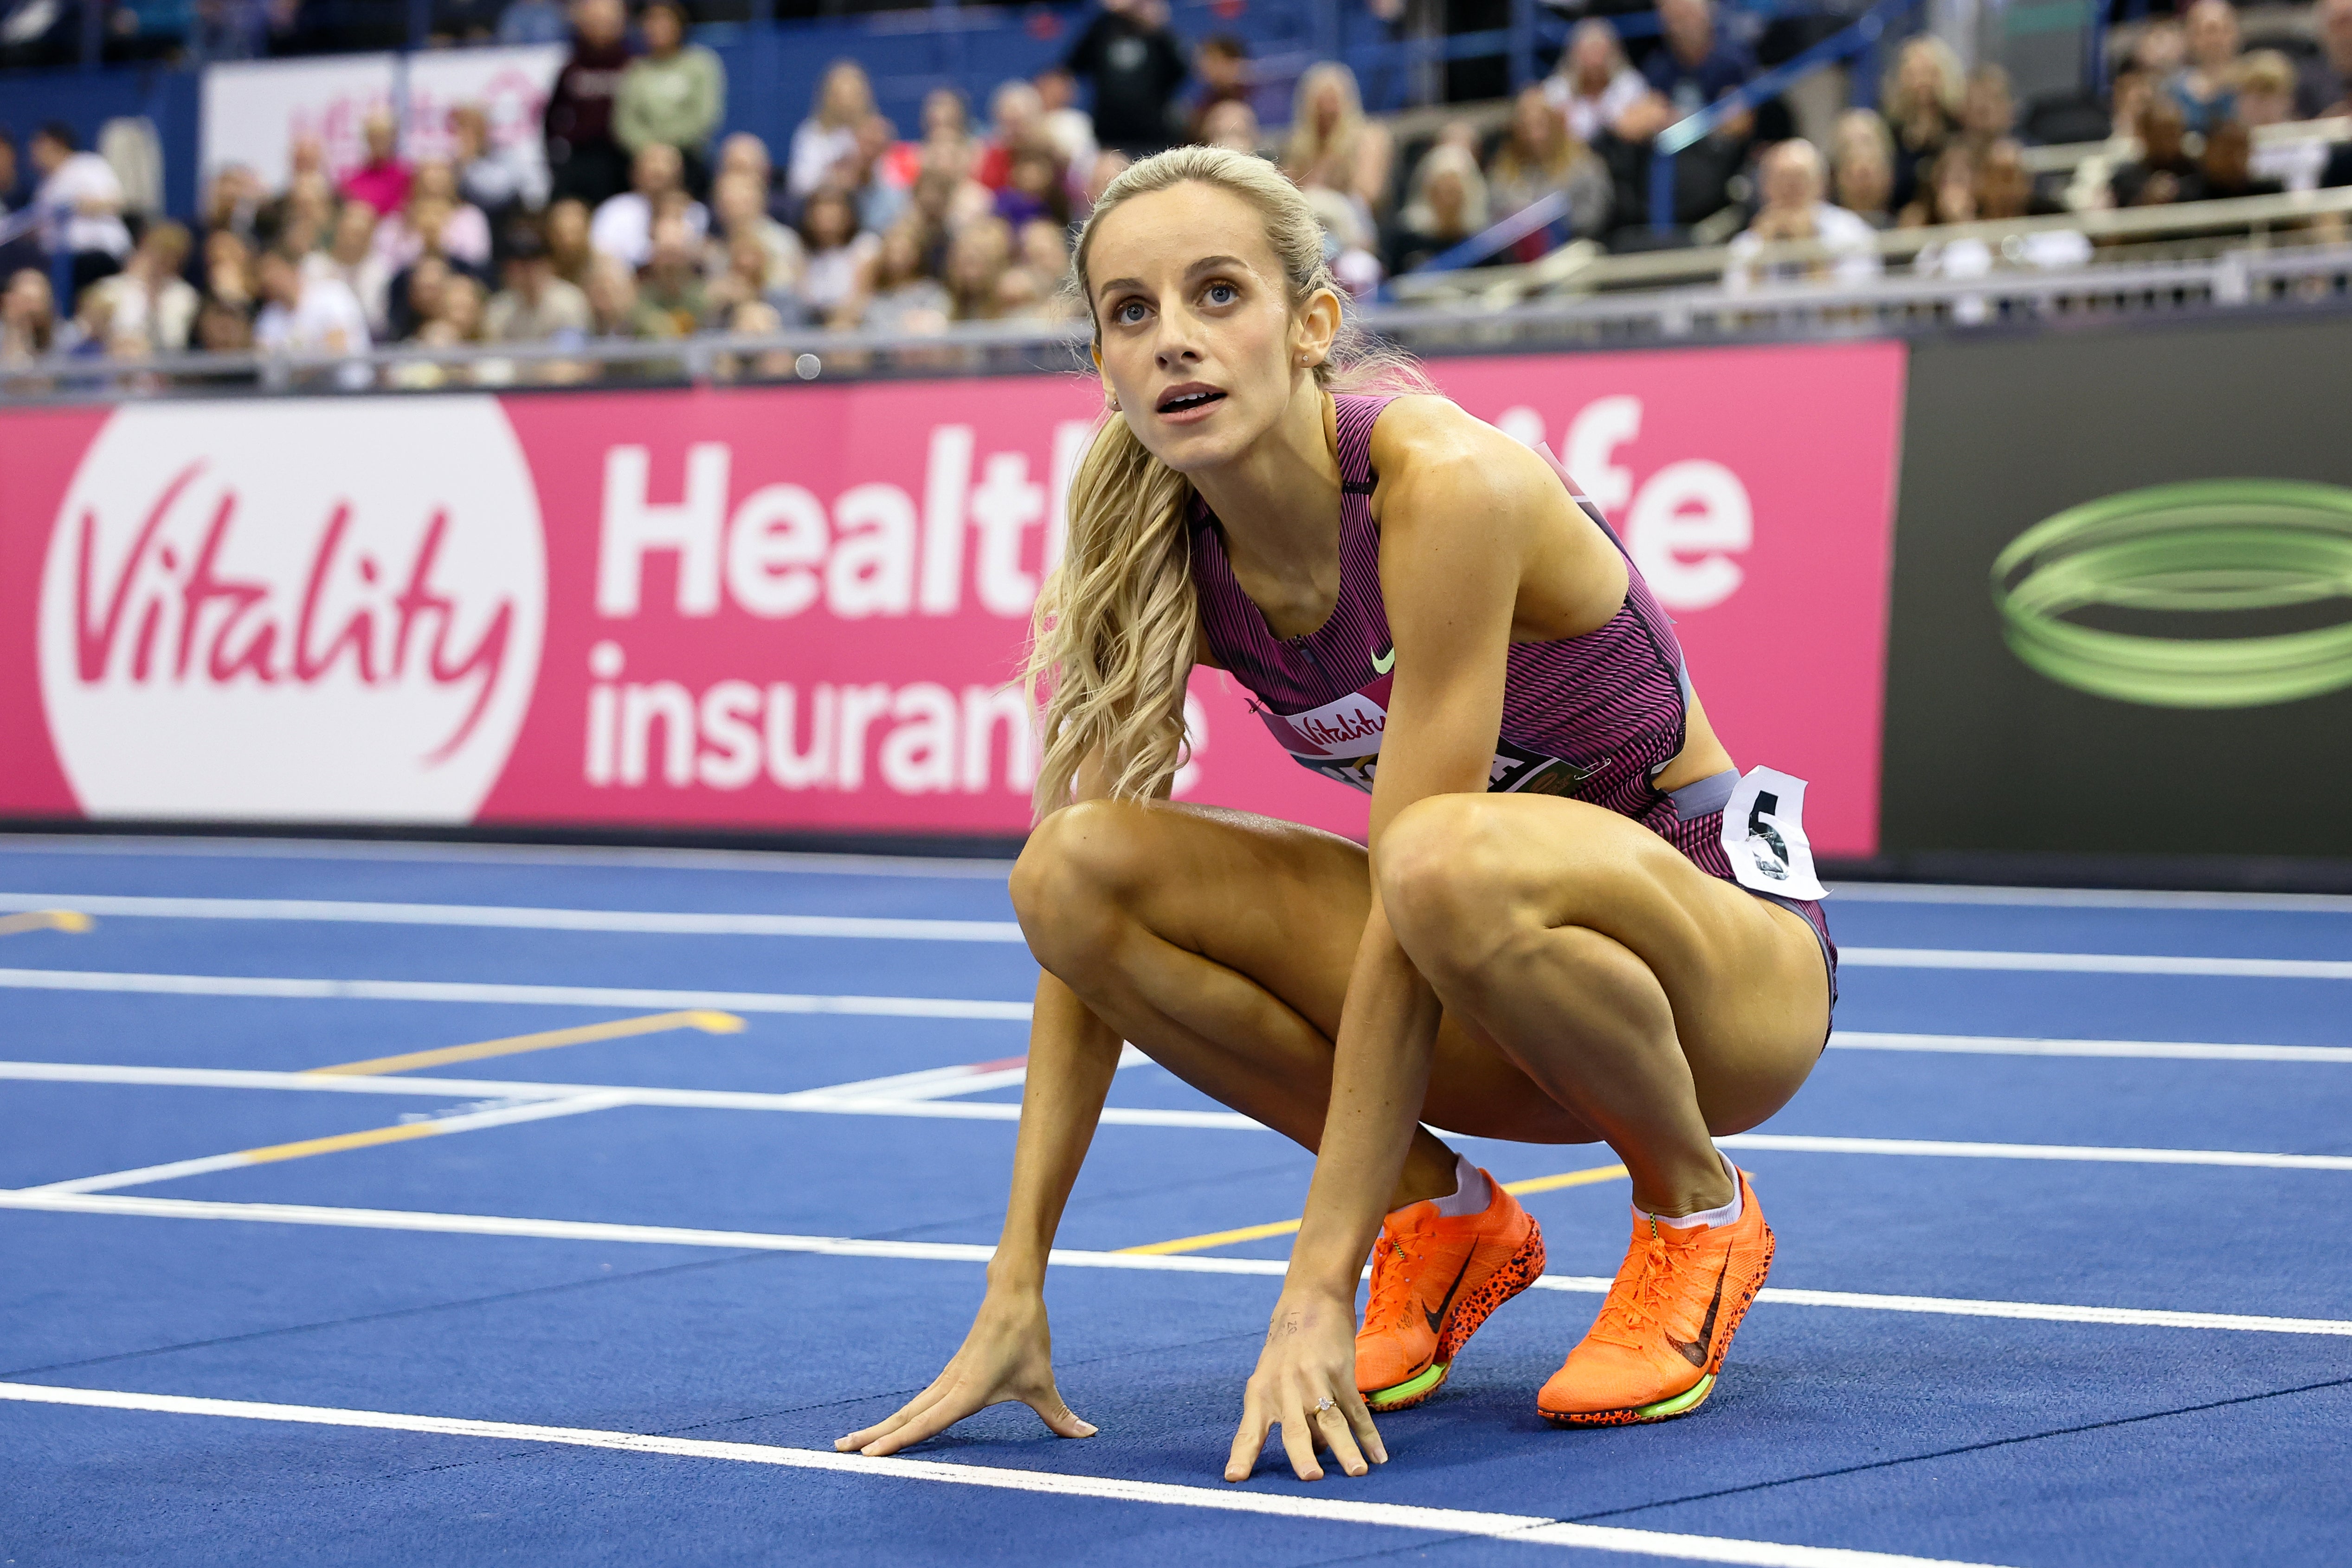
[1014, 794, 1828, 1213]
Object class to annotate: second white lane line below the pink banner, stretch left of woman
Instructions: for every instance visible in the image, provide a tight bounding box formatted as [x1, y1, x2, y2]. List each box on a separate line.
[0, 893, 1023, 942]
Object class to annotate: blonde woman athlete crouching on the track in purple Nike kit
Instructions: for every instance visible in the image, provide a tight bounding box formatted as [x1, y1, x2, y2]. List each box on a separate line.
[838, 148, 1835, 1481]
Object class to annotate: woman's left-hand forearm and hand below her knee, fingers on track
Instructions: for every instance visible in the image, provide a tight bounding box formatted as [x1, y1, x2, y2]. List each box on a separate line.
[832, 757, 1152, 1455]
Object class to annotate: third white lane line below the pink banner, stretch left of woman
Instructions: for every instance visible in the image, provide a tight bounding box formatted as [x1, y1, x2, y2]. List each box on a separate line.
[0, 968, 1030, 1023]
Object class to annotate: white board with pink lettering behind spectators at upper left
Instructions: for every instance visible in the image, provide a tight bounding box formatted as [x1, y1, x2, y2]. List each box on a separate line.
[202, 45, 565, 190]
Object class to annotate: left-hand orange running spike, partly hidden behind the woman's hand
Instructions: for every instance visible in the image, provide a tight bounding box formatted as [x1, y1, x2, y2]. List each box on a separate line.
[1355, 1171, 1543, 1411]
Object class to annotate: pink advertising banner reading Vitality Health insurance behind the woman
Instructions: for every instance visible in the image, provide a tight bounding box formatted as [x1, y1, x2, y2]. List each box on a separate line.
[0, 343, 1903, 856]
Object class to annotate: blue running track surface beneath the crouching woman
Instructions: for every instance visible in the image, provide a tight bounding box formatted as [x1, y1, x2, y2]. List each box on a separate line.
[0, 839, 2352, 1568]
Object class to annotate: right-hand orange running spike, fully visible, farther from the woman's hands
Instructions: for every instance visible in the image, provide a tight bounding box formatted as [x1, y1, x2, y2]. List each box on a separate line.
[1536, 1171, 1773, 1427]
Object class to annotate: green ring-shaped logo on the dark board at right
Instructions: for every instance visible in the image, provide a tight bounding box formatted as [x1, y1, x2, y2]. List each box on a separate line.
[1992, 479, 2352, 708]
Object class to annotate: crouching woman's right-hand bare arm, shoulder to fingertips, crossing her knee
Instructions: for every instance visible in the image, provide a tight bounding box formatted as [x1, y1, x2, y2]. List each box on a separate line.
[1225, 400, 1571, 1481]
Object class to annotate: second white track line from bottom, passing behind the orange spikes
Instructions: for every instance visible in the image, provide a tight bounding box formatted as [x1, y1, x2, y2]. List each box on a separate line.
[0, 1187, 2352, 1338]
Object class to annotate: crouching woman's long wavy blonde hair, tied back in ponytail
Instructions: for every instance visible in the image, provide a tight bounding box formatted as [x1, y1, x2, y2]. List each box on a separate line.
[1025, 146, 1430, 818]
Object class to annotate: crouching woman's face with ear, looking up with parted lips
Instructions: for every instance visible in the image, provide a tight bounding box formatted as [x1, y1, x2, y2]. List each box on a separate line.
[1087, 183, 1338, 472]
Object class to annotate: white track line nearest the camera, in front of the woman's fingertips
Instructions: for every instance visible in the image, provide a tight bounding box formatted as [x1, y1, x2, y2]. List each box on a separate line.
[0, 1382, 2013, 1568]
